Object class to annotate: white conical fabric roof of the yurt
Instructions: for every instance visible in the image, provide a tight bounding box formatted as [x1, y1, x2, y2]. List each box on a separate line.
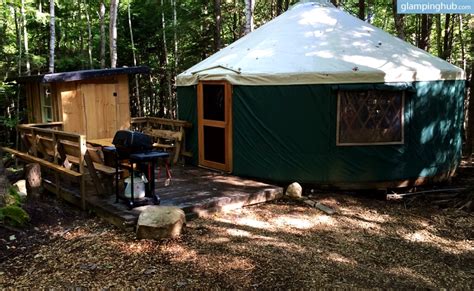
[176, 0, 465, 86]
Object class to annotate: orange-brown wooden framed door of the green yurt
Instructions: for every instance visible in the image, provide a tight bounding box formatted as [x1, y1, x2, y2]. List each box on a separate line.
[197, 81, 232, 172]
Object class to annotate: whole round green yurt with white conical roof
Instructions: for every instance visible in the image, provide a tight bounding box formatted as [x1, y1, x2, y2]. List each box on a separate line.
[177, 0, 465, 188]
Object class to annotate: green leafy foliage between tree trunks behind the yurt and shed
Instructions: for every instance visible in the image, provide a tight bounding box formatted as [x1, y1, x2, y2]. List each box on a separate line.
[0, 0, 474, 122]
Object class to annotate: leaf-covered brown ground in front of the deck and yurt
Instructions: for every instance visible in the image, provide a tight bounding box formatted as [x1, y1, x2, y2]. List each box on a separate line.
[0, 179, 474, 289]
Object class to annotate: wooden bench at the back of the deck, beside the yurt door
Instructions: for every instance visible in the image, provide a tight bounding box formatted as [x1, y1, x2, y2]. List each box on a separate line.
[131, 117, 192, 164]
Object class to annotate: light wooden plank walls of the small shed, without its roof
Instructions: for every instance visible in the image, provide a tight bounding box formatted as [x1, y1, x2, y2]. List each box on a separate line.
[25, 75, 131, 139]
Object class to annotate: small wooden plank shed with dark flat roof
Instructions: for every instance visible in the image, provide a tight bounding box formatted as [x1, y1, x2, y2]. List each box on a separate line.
[15, 67, 150, 139]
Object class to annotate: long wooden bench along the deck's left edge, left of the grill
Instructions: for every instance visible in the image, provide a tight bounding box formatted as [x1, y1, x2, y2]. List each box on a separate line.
[9, 125, 115, 209]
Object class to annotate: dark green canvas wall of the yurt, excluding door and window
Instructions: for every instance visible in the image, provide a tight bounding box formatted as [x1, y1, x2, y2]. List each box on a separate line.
[178, 80, 465, 184]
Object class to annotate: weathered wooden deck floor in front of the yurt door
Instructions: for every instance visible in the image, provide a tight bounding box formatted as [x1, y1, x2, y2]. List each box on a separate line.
[87, 165, 283, 229]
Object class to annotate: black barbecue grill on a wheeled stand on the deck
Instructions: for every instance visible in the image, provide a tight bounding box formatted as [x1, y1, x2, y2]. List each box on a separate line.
[109, 130, 171, 207]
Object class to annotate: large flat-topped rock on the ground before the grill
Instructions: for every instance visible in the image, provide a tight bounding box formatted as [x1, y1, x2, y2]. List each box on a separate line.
[137, 206, 186, 239]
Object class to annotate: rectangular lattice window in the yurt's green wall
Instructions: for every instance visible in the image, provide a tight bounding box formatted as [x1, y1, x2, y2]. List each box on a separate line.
[337, 90, 404, 145]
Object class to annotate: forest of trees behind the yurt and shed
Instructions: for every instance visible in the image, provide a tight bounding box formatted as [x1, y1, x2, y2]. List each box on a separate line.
[0, 0, 474, 155]
